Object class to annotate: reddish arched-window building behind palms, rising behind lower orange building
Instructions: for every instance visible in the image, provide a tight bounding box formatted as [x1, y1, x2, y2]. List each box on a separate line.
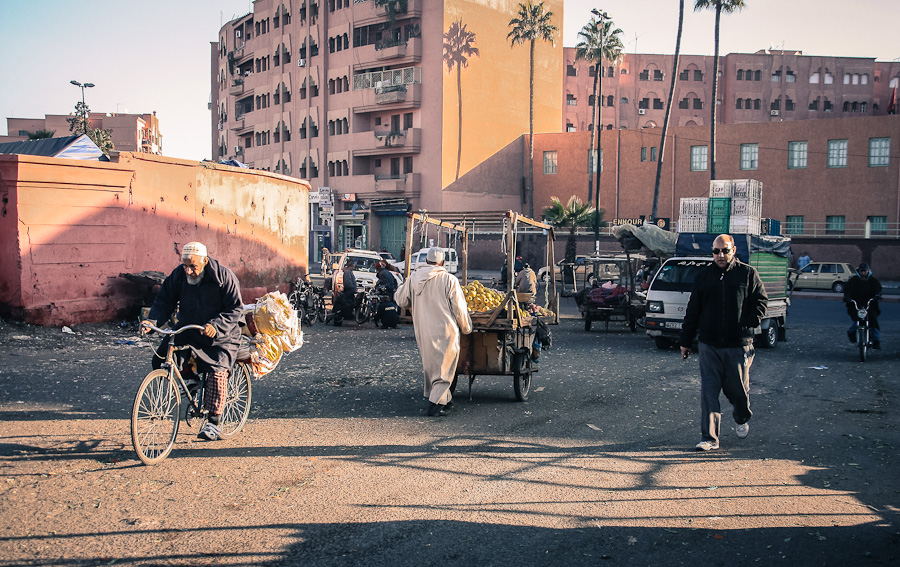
[562, 48, 900, 132]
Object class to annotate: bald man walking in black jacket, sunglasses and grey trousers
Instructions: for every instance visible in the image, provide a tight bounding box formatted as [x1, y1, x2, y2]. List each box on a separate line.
[679, 234, 769, 451]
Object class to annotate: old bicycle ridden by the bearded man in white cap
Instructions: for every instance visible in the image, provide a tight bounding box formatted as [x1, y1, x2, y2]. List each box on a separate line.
[131, 325, 252, 465]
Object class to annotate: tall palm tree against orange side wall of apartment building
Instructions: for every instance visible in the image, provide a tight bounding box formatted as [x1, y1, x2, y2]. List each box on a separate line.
[506, 0, 559, 218]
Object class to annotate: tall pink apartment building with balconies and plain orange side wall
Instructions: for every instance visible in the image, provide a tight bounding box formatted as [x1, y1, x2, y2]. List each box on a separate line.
[211, 0, 563, 259]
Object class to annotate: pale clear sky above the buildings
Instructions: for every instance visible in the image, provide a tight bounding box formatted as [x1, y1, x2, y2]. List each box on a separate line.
[0, 0, 900, 161]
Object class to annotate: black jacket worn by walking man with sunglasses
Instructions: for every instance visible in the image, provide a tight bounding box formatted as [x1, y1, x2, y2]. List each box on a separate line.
[679, 259, 769, 348]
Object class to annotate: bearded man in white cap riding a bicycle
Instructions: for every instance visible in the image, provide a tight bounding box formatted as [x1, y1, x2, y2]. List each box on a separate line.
[141, 242, 243, 441]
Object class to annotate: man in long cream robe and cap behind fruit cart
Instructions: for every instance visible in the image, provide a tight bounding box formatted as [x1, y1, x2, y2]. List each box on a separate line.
[394, 248, 472, 417]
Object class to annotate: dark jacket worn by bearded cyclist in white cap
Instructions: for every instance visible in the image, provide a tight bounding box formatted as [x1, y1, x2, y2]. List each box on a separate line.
[148, 258, 244, 368]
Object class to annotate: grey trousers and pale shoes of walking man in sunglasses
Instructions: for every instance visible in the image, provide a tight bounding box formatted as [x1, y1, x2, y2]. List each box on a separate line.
[699, 343, 755, 444]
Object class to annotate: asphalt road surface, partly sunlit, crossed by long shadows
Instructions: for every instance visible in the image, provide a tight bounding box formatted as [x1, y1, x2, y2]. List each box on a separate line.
[0, 296, 900, 566]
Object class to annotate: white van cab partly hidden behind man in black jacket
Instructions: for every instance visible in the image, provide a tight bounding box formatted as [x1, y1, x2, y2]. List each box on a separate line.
[645, 256, 713, 349]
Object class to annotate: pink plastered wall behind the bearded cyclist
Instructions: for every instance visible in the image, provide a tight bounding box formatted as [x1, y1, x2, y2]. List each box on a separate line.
[0, 153, 309, 325]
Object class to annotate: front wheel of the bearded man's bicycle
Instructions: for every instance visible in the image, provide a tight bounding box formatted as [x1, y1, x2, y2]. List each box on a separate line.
[131, 370, 181, 465]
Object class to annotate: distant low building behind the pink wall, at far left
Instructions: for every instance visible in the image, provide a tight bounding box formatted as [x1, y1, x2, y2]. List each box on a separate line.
[0, 112, 162, 155]
